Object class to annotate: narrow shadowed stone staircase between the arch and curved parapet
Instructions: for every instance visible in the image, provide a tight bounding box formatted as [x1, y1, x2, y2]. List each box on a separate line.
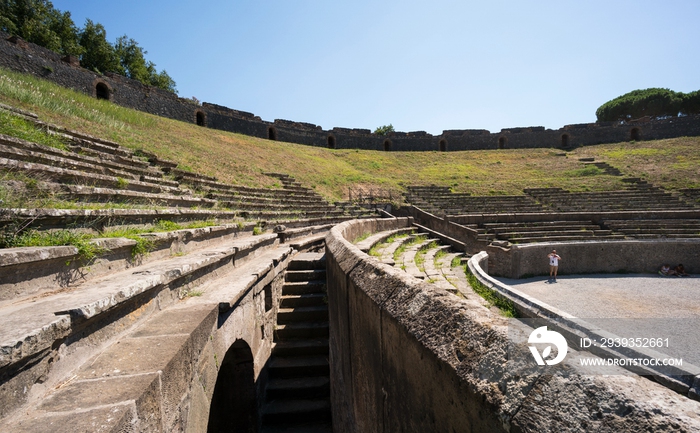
[262, 253, 332, 433]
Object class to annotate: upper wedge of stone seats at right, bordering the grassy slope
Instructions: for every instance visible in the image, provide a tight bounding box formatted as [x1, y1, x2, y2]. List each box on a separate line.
[525, 184, 695, 212]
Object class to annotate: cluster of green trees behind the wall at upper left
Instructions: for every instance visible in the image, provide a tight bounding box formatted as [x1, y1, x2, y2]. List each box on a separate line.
[0, 0, 176, 93]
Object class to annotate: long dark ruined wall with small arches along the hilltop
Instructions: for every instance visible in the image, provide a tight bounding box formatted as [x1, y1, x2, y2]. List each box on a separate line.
[5, 32, 700, 151]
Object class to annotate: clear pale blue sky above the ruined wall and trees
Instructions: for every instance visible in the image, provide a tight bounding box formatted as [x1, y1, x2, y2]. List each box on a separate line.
[53, 0, 700, 135]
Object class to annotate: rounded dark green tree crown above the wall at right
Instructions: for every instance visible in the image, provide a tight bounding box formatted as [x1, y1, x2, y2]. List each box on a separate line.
[596, 88, 700, 122]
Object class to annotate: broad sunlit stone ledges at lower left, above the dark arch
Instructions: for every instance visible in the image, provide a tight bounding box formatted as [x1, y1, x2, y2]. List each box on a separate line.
[0, 218, 331, 432]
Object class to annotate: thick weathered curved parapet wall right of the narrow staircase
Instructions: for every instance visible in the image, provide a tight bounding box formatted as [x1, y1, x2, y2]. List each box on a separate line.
[326, 218, 700, 433]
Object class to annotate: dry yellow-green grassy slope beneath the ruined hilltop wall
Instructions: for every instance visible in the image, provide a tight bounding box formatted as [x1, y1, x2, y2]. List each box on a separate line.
[0, 69, 700, 200]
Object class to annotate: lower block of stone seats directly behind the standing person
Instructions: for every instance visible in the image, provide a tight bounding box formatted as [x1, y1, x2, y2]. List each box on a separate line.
[477, 221, 625, 243]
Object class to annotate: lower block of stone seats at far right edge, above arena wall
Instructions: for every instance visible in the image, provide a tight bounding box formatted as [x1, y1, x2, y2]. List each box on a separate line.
[604, 219, 700, 238]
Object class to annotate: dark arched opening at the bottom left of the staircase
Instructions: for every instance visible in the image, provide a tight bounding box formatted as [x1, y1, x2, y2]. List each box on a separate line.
[207, 340, 258, 433]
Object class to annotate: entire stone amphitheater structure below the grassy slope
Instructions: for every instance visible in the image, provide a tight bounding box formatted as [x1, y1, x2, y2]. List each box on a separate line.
[0, 102, 700, 433]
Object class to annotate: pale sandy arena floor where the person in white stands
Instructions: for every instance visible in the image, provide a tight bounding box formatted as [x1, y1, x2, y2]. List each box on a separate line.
[499, 274, 700, 366]
